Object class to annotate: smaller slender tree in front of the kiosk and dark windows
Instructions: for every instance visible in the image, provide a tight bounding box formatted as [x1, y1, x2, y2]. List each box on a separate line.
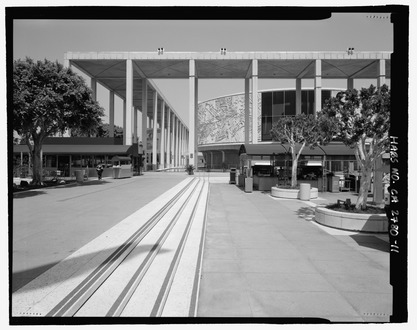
[271, 114, 337, 188]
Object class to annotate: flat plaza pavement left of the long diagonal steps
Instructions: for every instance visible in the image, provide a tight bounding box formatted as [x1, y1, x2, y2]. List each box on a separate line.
[12, 172, 186, 292]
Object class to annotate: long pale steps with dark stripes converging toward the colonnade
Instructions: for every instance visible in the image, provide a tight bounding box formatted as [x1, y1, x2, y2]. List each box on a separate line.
[12, 177, 209, 317]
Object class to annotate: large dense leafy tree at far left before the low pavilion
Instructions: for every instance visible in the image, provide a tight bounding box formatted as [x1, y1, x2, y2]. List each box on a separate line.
[13, 58, 104, 184]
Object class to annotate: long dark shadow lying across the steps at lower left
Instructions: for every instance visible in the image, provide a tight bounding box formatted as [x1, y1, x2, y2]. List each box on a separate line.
[11, 243, 168, 293]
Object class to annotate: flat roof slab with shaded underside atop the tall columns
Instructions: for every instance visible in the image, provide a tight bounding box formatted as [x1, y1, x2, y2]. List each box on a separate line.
[65, 51, 391, 123]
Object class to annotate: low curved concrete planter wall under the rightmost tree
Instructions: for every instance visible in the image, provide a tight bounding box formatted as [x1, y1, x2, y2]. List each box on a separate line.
[315, 206, 388, 233]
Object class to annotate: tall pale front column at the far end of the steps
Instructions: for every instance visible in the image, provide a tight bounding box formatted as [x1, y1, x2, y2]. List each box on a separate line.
[188, 60, 197, 168]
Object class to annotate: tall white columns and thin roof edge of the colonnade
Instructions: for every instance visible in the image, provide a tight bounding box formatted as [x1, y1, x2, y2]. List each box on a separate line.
[66, 53, 387, 169]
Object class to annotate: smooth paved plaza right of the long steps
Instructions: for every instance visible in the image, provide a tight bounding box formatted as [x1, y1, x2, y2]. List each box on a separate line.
[198, 175, 392, 322]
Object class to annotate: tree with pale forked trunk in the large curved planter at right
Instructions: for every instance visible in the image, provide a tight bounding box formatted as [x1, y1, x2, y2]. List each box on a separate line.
[322, 85, 391, 210]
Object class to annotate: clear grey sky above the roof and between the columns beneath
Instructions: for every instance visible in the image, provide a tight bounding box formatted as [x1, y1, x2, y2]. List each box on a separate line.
[13, 9, 393, 126]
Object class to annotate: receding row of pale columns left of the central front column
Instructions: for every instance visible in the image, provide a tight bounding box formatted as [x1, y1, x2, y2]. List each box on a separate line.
[66, 60, 190, 170]
